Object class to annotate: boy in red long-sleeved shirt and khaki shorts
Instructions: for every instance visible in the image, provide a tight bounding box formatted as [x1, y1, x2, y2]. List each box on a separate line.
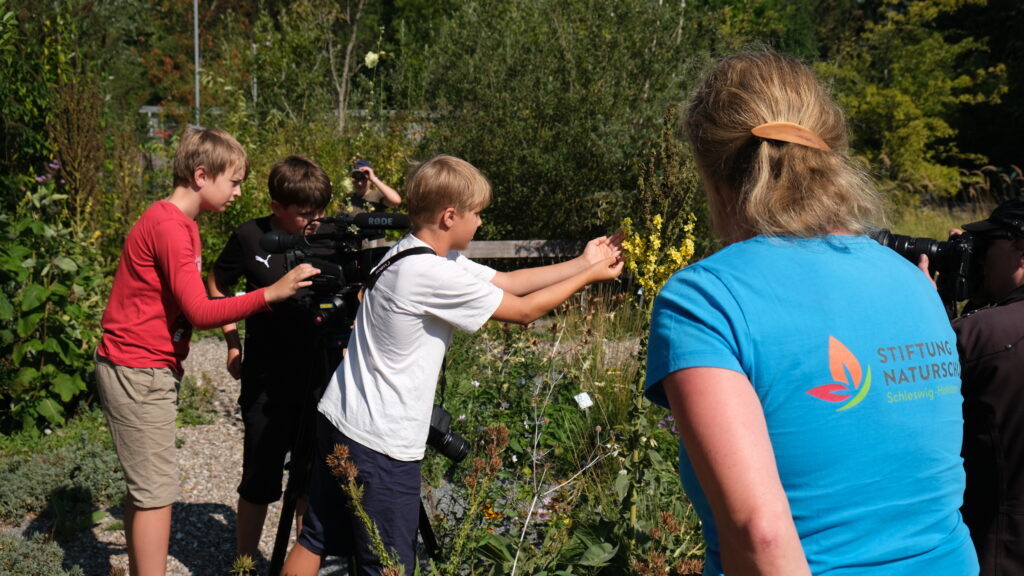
[95, 128, 319, 576]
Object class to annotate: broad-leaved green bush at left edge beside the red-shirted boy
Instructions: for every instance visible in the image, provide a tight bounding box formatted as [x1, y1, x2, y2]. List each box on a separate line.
[0, 178, 109, 433]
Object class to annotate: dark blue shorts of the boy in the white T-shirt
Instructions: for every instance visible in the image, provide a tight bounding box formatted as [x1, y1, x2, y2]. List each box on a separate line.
[299, 413, 420, 576]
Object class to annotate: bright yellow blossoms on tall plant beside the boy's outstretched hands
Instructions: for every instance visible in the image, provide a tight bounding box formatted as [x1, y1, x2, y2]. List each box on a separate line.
[622, 214, 696, 306]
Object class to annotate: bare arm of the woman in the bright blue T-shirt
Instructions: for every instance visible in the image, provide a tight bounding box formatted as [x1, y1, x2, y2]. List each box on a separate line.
[663, 368, 811, 575]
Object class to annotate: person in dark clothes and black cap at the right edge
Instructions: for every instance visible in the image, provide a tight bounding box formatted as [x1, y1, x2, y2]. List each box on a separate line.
[953, 198, 1024, 576]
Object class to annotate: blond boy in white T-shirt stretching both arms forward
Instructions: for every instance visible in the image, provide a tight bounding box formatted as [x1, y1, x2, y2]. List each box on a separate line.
[283, 156, 623, 576]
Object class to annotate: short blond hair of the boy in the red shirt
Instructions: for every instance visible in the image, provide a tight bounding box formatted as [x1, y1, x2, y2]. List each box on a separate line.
[174, 127, 249, 187]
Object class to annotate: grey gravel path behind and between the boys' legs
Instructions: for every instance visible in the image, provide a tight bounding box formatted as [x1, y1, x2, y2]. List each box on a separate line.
[58, 338, 347, 576]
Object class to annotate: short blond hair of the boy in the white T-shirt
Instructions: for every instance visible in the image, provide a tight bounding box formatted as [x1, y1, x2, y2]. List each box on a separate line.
[406, 155, 490, 228]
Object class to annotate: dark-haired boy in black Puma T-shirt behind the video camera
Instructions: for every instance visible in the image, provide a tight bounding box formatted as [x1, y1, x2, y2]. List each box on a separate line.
[207, 156, 340, 559]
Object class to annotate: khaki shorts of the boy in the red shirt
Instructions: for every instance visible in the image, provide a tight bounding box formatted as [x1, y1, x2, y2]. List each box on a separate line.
[95, 354, 179, 508]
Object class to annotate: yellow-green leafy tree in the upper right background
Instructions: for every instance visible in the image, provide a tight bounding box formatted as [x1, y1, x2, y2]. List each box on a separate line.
[818, 0, 1006, 196]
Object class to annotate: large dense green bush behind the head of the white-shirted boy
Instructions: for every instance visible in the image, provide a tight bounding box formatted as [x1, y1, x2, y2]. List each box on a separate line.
[399, 0, 690, 238]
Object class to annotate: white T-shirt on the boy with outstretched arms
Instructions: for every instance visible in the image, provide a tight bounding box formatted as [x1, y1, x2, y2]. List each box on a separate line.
[317, 230, 504, 461]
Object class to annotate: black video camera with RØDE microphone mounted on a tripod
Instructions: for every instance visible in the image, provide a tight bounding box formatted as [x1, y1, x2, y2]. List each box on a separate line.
[260, 212, 411, 336]
